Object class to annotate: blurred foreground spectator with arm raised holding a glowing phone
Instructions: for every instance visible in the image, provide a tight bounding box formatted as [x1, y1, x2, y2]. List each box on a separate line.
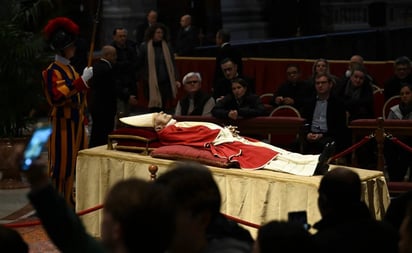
[9, 145, 176, 253]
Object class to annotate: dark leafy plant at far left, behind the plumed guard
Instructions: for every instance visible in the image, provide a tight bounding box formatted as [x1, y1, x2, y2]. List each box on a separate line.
[0, 0, 53, 138]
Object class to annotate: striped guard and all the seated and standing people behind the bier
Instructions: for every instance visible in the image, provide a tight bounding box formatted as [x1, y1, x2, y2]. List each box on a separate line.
[36, 10, 412, 205]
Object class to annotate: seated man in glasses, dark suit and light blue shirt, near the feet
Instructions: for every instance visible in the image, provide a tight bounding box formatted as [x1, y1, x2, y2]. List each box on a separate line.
[301, 73, 350, 154]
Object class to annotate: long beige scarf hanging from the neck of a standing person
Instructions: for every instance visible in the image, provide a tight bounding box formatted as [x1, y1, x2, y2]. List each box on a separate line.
[147, 40, 177, 108]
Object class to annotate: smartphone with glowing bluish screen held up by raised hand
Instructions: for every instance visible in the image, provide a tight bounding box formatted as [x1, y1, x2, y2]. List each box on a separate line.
[21, 124, 52, 171]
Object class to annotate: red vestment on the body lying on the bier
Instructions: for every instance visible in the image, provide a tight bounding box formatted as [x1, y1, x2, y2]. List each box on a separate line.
[158, 125, 278, 169]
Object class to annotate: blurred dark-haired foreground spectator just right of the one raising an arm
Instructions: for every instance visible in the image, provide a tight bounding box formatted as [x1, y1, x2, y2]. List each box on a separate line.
[156, 162, 253, 253]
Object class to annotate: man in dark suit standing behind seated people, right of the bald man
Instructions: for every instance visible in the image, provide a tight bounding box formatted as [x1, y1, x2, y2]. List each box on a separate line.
[214, 30, 243, 84]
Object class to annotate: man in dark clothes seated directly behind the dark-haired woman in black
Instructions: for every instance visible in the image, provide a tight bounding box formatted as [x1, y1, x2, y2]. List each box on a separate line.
[212, 58, 255, 100]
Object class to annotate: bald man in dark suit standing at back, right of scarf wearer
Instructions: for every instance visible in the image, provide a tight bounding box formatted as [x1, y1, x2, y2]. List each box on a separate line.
[175, 14, 200, 56]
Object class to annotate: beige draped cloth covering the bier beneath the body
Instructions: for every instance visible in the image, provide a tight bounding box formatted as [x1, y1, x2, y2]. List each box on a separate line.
[76, 145, 390, 237]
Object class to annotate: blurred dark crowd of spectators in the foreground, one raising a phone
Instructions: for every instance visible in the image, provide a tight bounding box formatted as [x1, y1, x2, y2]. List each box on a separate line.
[0, 145, 412, 253]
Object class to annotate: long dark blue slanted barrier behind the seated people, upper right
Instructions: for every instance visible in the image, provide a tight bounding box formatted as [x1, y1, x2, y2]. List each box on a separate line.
[196, 27, 412, 61]
